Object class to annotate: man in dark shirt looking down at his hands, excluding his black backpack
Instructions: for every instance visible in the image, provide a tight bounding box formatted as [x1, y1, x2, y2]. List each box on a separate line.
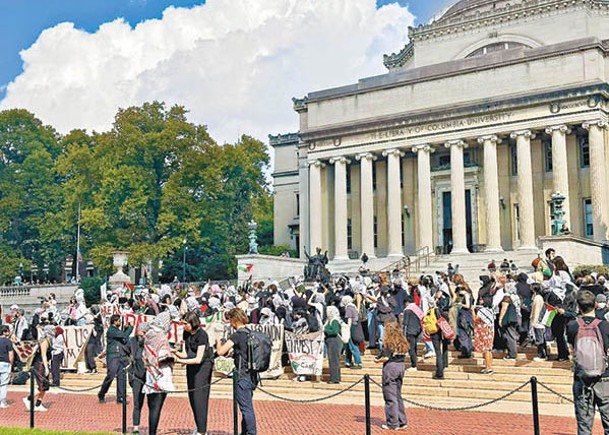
[216, 308, 257, 435]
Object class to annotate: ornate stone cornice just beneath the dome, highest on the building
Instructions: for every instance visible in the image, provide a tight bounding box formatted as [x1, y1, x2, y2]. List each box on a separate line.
[408, 0, 609, 42]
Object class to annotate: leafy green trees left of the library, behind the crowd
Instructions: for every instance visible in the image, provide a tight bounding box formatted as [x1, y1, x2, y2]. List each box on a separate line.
[0, 102, 273, 282]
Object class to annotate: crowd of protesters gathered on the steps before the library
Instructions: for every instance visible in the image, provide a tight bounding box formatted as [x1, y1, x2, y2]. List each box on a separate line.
[0, 249, 609, 434]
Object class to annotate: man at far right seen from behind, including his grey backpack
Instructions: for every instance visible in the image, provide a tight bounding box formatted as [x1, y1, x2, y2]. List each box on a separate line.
[567, 290, 609, 435]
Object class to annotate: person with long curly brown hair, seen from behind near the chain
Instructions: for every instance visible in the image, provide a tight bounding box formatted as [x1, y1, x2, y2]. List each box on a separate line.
[376, 320, 409, 430]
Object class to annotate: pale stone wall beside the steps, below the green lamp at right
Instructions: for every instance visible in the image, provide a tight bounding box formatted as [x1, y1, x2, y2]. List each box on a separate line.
[539, 235, 609, 269]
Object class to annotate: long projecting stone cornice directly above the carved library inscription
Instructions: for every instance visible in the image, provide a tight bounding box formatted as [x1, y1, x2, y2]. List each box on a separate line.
[301, 83, 609, 143]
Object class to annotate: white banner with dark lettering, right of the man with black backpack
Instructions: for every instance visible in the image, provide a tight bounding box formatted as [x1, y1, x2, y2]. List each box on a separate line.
[285, 331, 324, 376]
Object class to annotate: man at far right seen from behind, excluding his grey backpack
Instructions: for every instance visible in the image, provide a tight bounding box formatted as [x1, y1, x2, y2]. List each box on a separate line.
[567, 290, 609, 435]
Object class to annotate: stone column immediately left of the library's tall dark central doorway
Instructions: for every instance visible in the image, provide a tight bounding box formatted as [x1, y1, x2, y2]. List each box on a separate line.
[412, 144, 434, 252]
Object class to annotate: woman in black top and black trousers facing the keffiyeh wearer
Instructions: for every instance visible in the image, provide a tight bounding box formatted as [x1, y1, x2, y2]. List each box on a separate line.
[175, 311, 214, 435]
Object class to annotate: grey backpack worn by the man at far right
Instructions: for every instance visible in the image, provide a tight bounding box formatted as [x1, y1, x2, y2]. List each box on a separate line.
[574, 319, 607, 378]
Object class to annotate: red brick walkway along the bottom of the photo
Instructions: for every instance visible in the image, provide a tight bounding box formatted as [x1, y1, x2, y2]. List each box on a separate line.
[0, 392, 603, 435]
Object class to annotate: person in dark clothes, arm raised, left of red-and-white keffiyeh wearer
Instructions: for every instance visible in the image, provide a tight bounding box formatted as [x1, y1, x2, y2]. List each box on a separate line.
[97, 314, 133, 403]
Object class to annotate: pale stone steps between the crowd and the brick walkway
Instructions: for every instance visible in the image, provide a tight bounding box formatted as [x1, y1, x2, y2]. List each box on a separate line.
[56, 344, 572, 415]
